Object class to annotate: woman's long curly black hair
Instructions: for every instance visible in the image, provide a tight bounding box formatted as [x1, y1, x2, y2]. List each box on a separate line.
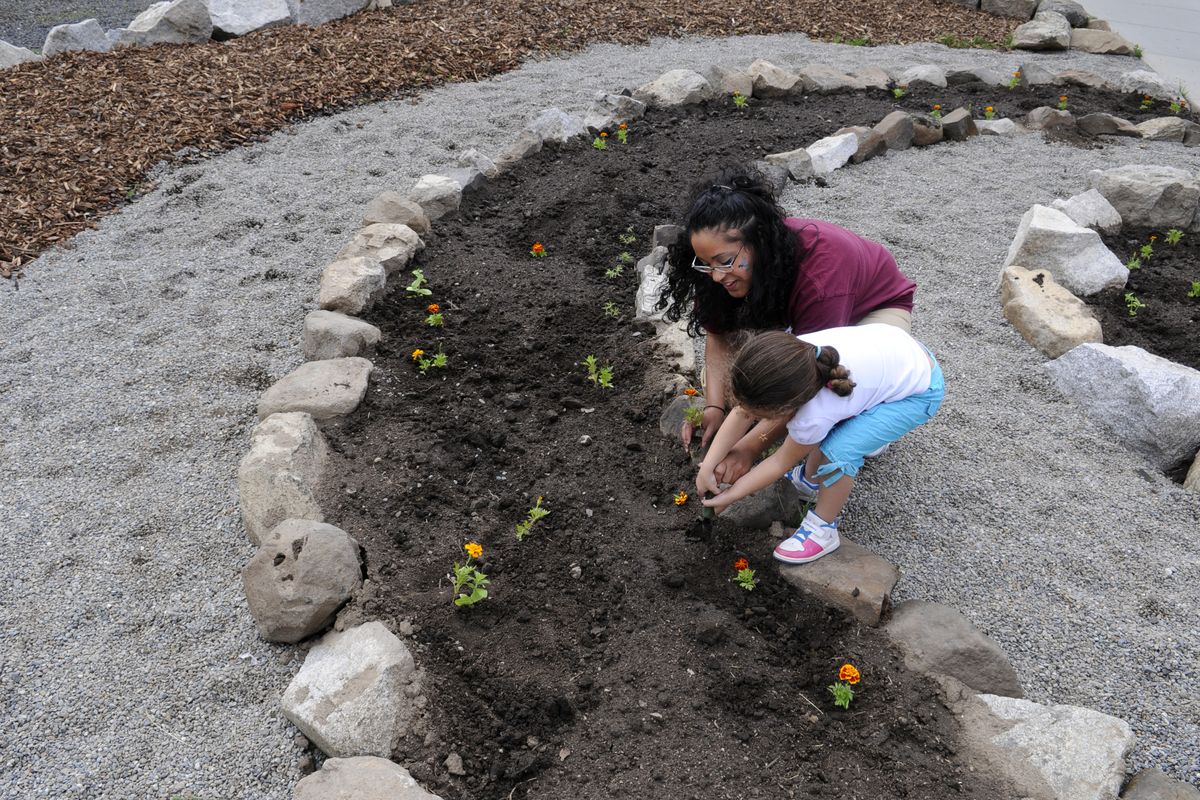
[658, 166, 797, 336]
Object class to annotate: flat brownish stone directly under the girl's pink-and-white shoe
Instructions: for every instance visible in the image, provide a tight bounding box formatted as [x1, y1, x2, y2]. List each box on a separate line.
[770, 523, 900, 625]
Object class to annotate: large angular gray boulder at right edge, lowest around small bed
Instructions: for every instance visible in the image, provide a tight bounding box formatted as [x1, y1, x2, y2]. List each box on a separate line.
[1046, 344, 1200, 471]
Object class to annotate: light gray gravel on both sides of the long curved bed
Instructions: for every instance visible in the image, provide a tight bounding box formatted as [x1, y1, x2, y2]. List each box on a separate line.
[0, 28, 1200, 800]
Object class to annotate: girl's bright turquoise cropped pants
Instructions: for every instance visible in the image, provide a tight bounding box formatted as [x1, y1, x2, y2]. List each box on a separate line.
[816, 350, 946, 486]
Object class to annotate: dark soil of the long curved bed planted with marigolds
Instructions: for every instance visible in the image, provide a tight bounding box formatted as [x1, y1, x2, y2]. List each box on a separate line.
[323, 84, 1142, 800]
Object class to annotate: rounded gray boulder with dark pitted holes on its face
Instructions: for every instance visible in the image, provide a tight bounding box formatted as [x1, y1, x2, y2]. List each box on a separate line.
[241, 519, 362, 642]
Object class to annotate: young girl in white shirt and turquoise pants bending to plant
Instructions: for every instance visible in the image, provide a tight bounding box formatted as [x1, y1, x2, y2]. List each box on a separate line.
[696, 324, 946, 564]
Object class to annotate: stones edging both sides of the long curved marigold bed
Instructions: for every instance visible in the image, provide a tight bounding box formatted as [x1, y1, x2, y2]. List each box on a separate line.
[231, 53, 1190, 798]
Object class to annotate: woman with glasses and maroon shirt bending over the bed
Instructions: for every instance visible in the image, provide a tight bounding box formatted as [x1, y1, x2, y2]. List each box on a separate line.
[659, 167, 917, 483]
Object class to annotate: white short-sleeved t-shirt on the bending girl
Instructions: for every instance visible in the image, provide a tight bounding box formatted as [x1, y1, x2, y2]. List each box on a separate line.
[787, 323, 932, 445]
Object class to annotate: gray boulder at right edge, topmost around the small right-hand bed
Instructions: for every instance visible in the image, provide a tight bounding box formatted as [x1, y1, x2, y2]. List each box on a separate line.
[1087, 164, 1200, 230]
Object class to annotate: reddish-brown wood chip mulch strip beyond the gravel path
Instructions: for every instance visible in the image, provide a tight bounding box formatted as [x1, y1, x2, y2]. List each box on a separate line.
[0, 0, 1016, 277]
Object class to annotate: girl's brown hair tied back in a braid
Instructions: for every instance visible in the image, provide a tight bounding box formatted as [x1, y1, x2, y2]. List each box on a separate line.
[730, 331, 854, 417]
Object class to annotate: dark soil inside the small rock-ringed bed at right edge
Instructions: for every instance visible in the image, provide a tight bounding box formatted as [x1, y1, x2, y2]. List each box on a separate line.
[1087, 230, 1200, 369]
